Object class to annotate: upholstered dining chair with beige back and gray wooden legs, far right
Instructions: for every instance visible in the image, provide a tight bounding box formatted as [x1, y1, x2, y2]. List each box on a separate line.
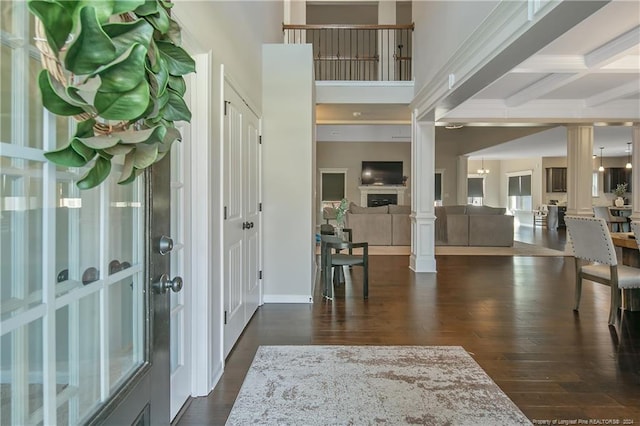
[564, 216, 640, 325]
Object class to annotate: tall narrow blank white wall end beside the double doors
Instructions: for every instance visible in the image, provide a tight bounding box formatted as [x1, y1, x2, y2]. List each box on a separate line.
[262, 44, 316, 303]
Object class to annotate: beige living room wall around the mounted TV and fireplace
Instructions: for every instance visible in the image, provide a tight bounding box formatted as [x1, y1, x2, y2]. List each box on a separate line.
[316, 142, 411, 215]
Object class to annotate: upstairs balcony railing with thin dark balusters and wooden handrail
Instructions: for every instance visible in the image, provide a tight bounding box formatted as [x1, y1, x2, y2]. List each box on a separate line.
[282, 24, 414, 81]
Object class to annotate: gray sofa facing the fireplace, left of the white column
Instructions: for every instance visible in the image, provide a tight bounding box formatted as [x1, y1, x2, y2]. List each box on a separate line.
[345, 203, 411, 246]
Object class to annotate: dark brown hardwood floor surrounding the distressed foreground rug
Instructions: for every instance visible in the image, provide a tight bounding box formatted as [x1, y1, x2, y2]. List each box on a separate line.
[177, 227, 640, 425]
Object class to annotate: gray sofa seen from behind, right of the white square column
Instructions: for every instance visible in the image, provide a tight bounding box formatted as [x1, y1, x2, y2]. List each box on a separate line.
[435, 205, 514, 247]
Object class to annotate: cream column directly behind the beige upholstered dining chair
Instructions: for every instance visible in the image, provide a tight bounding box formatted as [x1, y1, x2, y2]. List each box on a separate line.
[567, 126, 593, 216]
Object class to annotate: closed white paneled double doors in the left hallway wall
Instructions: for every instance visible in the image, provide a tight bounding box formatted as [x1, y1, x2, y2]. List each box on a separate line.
[223, 82, 261, 357]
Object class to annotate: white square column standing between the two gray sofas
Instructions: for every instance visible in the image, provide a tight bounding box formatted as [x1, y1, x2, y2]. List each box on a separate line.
[409, 111, 436, 272]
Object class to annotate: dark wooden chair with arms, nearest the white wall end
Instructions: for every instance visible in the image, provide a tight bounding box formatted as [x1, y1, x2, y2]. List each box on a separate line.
[320, 235, 369, 299]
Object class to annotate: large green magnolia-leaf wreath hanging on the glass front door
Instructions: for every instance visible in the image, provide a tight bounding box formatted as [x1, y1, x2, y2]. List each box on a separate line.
[28, 0, 195, 189]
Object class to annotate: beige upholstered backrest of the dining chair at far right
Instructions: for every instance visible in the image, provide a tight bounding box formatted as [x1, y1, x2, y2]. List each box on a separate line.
[564, 216, 618, 265]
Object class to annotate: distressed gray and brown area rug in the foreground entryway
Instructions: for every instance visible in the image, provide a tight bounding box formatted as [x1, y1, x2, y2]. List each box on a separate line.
[226, 346, 531, 426]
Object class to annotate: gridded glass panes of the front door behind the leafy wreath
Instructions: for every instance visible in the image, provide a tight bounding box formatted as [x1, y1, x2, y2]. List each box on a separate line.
[0, 1, 149, 424]
